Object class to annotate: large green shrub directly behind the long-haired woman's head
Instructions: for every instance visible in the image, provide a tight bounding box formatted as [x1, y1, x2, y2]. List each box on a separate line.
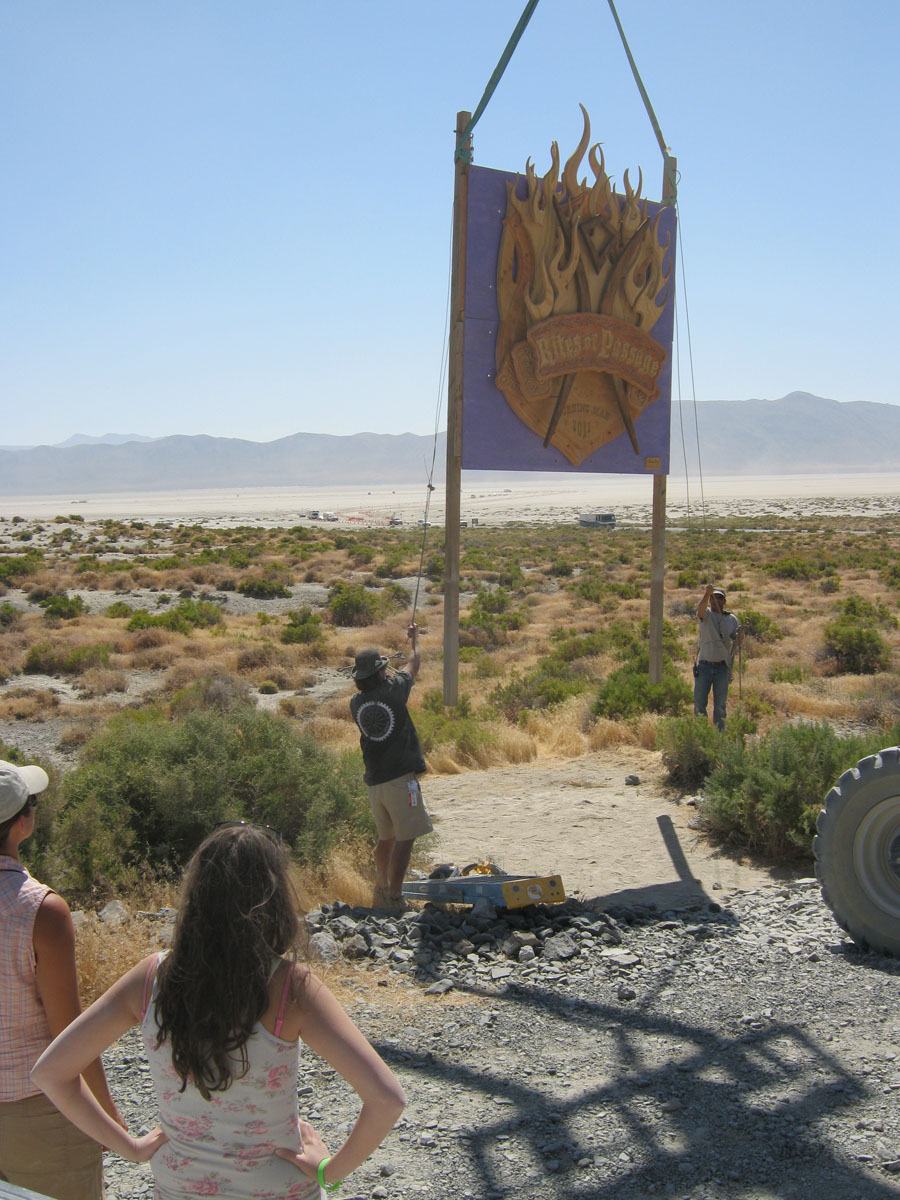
[56, 702, 371, 893]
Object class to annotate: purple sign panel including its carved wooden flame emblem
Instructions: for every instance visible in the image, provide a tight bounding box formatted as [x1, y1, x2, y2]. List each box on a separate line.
[462, 164, 676, 474]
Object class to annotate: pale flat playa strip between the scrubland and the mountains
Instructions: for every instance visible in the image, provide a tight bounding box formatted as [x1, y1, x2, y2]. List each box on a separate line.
[0, 466, 900, 526]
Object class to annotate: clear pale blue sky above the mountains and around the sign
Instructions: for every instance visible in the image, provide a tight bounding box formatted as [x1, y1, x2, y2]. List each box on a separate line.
[0, 0, 900, 445]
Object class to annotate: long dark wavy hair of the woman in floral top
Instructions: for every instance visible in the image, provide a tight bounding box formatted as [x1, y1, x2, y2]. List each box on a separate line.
[156, 824, 299, 1099]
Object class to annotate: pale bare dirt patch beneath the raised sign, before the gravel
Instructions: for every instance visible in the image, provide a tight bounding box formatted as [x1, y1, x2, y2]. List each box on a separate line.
[424, 746, 796, 908]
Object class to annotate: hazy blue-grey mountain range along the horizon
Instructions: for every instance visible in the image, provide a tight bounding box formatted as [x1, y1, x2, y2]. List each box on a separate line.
[0, 391, 900, 496]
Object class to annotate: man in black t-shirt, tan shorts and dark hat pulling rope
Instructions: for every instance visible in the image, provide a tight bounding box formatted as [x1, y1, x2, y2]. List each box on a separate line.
[350, 622, 432, 907]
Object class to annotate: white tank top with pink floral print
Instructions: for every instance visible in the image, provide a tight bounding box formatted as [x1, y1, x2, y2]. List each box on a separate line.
[140, 962, 320, 1200]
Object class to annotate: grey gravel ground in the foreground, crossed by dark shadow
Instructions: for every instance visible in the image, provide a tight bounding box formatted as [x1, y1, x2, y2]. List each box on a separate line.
[100, 881, 900, 1200]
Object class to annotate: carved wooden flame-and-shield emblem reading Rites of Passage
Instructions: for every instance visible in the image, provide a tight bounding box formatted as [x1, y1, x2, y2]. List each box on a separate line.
[496, 104, 670, 467]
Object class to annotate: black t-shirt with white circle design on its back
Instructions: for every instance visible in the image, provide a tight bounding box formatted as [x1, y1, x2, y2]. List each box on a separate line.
[350, 671, 425, 784]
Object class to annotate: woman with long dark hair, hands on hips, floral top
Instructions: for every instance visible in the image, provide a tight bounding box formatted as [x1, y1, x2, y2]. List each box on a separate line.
[32, 823, 406, 1200]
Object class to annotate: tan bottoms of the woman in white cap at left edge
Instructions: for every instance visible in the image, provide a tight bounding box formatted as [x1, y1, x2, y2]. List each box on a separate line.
[0, 1093, 104, 1200]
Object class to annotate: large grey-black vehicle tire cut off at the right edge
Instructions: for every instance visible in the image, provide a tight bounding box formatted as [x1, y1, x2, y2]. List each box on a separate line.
[812, 746, 900, 955]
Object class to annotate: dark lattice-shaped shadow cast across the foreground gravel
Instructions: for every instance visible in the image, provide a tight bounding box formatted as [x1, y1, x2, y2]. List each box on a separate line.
[378, 985, 900, 1200]
